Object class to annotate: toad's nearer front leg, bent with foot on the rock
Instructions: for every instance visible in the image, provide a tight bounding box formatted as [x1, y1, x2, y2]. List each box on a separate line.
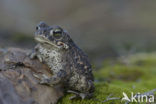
[40, 70, 67, 86]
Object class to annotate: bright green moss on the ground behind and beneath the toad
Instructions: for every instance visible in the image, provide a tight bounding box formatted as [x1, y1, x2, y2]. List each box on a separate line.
[59, 53, 156, 104]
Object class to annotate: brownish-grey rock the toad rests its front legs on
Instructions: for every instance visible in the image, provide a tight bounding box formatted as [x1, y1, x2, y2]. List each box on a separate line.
[0, 48, 63, 104]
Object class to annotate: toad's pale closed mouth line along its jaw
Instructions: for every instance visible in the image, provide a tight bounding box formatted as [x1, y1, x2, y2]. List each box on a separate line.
[35, 35, 61, 48]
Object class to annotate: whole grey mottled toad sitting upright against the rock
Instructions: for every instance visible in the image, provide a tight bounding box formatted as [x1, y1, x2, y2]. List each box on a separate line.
[30, 22, 94, 99]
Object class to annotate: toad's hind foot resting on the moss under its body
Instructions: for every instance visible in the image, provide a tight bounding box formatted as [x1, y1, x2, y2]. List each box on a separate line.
[67, 90, 93, 100]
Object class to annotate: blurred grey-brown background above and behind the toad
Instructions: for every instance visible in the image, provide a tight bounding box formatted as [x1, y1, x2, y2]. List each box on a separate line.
[0, 0, 156, 67]
